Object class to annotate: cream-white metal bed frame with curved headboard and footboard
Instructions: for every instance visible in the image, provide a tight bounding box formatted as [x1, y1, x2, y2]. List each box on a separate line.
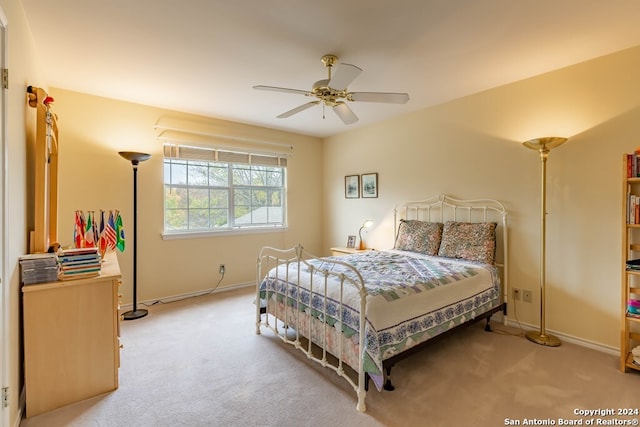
[256, 194, 509, 412]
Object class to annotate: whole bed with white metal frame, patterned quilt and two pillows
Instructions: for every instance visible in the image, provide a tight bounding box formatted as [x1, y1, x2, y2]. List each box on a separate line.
[256, 194, 508, 412]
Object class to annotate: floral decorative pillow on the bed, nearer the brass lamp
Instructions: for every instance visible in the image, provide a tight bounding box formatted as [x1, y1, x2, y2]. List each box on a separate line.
[438, 221, 498, 264]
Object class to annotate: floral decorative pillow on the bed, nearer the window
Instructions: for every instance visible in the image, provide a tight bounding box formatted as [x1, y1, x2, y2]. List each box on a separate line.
[394, 219, 443, 255]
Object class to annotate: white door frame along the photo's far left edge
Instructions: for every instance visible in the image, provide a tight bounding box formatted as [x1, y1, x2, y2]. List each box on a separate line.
[0, 7, 11, 427]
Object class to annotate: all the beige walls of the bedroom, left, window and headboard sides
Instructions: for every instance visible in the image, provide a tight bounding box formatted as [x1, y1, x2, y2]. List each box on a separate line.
[5, 0, 640, 425]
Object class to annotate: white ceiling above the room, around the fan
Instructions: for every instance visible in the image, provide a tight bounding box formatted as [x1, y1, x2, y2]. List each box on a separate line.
[22, 0, 640, 137]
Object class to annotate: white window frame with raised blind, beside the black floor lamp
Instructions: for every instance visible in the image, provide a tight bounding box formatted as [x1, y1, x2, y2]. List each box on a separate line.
[162, 142, 287, 240]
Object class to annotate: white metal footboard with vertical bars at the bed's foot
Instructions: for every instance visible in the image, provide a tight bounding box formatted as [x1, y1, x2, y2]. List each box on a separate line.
[256, 246, 367, 412]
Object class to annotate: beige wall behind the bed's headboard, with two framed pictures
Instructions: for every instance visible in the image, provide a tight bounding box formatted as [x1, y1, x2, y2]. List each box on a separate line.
[323, 47, 640, 349]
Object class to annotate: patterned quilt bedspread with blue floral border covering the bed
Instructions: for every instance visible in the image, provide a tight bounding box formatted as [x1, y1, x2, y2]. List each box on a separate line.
[260, 250, 500, 390]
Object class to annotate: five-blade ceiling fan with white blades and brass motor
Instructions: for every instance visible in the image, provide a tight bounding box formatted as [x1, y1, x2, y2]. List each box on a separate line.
[253, 55, 409, 125]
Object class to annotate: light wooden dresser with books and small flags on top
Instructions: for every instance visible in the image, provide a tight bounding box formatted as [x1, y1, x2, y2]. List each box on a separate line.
[22, 252, 120, 417]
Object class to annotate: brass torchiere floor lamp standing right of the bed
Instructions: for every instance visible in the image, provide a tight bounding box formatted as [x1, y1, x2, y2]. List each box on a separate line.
[523, 137, 567, 347]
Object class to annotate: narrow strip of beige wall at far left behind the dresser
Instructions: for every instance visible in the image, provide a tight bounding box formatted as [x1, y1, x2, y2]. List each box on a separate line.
[0, 0, 44, 425]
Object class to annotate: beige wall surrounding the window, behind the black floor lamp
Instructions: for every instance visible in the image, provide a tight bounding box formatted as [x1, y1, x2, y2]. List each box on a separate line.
[50, 88, 322, 303]
